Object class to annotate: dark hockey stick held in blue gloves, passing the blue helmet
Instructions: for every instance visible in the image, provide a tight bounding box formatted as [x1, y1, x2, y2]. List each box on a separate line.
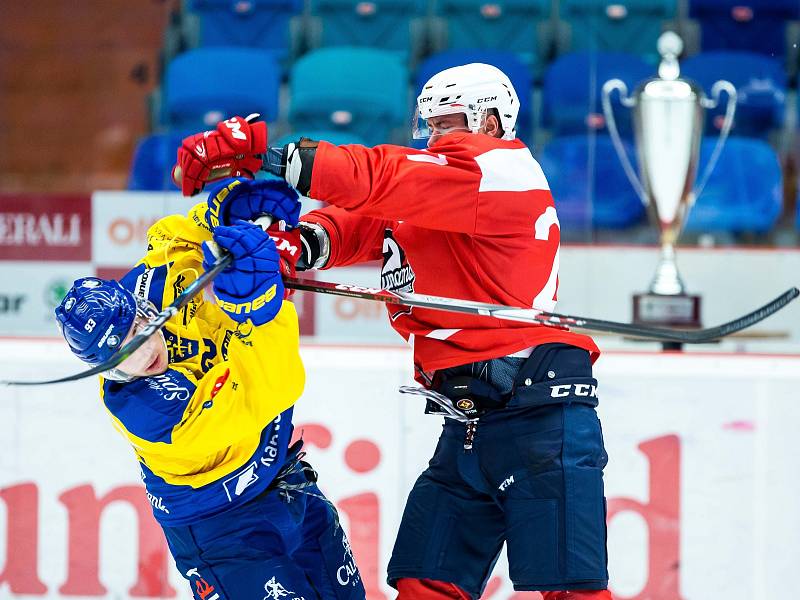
[0, 252, 233, 385]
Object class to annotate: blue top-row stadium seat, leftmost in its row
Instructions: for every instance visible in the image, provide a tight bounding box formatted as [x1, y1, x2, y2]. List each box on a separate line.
[186, 0, 303, 60]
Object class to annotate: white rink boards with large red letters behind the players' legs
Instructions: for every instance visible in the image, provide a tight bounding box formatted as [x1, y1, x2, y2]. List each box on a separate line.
[0, 340, 800, 600]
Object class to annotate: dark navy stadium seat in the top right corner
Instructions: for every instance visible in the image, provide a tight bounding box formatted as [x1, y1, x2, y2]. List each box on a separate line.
[689, 0, 800, 58]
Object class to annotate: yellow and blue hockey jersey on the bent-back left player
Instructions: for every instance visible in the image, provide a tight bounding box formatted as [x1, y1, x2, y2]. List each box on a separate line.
[97, 204, 305, 525]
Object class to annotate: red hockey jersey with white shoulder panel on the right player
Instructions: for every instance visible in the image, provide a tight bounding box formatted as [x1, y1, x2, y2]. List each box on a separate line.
[303, 133, 599, 382]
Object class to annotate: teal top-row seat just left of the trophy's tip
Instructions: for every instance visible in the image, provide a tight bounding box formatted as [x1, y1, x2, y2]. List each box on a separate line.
[559, 0, 677, 64]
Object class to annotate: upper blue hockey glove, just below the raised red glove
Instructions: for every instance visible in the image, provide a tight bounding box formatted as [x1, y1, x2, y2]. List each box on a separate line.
[206, 177, 300, 230]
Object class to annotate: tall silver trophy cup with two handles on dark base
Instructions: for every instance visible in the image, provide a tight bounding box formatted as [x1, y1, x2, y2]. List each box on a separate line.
[602, 31, 736, 327]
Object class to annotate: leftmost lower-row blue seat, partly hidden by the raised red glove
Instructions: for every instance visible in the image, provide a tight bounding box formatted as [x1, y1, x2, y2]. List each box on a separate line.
[127, 131, 191, 192]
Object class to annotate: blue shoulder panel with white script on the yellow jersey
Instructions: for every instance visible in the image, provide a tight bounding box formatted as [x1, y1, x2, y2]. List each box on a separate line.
[103, 369, 196, 443]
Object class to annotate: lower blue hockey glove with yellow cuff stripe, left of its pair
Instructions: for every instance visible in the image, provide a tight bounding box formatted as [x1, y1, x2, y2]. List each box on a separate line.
[203, 221, 285, 325]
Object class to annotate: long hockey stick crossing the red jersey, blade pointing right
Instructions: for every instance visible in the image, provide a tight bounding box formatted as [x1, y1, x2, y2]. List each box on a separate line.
[284, 278, 800, 344]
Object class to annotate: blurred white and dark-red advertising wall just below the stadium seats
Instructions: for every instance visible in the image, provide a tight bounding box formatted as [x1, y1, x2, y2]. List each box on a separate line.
[0, 191, 800, 351]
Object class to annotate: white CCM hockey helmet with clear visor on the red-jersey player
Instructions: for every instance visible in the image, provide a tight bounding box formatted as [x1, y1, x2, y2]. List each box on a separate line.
[413, 63, 519, 140]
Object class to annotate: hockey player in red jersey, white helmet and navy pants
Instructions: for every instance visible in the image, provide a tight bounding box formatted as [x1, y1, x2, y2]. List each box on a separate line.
[174, 63, 611, 600]
